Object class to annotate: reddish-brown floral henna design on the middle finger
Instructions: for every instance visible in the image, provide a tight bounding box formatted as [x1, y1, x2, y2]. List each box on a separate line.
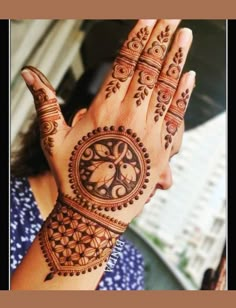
[134, 26, 170, 106]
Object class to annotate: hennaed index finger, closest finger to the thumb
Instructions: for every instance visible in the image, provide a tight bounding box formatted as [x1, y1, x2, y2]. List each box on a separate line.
[91, 19, 156, 103]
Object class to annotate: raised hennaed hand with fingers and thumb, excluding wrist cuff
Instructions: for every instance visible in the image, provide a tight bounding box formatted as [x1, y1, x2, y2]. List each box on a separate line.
[22, 20, 195, 223]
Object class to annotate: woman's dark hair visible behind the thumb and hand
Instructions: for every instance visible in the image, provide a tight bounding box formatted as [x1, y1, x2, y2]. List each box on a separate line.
[11, 62, 111, 177]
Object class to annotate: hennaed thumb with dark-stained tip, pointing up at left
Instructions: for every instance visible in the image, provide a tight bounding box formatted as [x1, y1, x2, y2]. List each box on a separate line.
[21, 66, 66, 155]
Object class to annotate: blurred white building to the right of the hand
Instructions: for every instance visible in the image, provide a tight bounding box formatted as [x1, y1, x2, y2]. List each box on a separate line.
[136, 113, 226, 288]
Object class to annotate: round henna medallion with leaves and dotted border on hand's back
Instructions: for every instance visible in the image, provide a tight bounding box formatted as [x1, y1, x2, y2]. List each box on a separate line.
[69, 126, 150, 211]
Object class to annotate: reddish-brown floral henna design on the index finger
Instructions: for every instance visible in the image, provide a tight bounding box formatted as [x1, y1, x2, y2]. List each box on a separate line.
[105, 27, 149, 99]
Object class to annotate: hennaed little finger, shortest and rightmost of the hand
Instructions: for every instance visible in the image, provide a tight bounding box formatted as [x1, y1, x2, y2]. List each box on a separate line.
[162, 71, 196, 150]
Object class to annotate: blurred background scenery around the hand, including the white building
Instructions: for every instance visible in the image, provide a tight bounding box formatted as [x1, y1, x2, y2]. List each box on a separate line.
[11, 20, 227, 290]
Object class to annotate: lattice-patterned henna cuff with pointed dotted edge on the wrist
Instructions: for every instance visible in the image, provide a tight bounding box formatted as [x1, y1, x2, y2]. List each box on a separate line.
[39, 197, 119, 281]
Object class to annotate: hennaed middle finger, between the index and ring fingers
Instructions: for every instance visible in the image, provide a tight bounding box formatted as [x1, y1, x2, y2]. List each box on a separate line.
[121, 19, 180, 115]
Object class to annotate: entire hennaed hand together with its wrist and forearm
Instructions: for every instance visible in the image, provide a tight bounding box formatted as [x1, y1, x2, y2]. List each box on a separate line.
[11, 20, 195, 290]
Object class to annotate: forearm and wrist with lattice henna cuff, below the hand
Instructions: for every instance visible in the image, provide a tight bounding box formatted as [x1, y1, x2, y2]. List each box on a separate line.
[11, 196, 127, 290]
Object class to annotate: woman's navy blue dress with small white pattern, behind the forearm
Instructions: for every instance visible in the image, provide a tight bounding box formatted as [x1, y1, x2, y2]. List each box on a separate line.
[10, 177, 144, 290]
